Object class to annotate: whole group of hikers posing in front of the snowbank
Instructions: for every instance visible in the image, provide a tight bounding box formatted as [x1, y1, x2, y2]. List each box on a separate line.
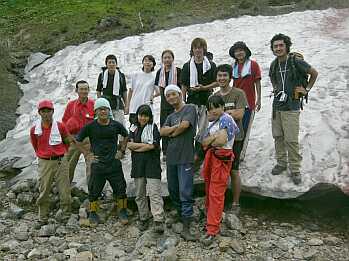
[30, 34, 317, 245]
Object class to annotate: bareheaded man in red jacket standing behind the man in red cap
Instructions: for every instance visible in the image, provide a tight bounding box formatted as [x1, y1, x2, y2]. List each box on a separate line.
[62, 80, 94, 184]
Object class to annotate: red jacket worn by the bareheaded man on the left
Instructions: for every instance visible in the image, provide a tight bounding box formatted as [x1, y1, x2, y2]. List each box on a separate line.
[62, 99, 95, 135]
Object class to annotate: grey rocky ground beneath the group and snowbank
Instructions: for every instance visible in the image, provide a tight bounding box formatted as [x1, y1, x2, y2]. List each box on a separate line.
[0, 180, 349, 261]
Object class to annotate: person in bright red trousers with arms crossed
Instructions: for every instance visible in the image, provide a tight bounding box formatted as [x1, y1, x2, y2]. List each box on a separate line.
[201, 95, 239, 245]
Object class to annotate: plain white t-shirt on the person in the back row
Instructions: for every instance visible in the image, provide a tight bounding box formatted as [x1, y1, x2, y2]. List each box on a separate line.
[130, 71, 157, 113]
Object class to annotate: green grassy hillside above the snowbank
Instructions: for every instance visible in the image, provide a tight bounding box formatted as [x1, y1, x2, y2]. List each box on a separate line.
[0, 0, 348, 53]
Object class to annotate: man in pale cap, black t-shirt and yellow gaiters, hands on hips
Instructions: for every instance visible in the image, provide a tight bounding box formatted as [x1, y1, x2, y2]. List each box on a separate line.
[76, 98, 128, 226]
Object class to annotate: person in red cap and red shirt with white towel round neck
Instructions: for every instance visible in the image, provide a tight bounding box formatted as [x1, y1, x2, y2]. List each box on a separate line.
[30, 100, 72, 224]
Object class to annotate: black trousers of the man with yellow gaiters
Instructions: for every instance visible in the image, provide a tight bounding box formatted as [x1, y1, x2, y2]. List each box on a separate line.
[88, 159, 126, 202]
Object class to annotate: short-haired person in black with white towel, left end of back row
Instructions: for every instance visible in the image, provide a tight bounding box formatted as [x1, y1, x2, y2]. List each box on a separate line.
[97, 54, 127, 126]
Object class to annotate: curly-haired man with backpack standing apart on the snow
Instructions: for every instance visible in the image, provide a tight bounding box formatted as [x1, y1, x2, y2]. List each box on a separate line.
[269, 34, 318, 185]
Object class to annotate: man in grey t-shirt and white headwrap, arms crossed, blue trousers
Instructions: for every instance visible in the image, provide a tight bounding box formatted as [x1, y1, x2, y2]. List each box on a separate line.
[160, 85, 197, 241]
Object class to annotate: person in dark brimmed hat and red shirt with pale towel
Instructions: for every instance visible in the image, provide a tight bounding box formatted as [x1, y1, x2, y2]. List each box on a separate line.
[229, 41, 261, 161]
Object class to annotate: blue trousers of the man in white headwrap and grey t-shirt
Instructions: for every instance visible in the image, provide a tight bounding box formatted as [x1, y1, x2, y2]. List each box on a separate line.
[167, 163, 194, 218]
